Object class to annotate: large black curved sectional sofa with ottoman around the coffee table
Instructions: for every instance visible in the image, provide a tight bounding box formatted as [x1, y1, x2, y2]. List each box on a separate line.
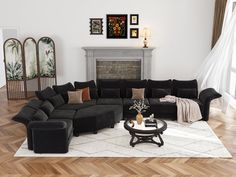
[13, 80, 221, 153]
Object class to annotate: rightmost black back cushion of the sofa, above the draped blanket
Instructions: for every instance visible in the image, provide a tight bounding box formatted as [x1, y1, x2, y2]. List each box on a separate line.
[173, 79, 198, 98]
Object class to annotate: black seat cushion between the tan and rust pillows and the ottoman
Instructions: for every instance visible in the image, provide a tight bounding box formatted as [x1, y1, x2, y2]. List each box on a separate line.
[57, 99, 96, 110]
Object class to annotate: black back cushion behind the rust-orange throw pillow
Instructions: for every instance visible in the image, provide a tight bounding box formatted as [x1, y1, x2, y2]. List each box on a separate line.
[74, 80, 98, 99]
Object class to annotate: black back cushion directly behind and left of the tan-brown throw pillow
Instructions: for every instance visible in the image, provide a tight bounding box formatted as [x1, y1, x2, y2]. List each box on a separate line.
[52, 82, 75, 103]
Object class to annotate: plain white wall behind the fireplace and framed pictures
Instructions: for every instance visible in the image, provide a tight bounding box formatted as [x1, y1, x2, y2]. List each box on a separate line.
[0, 0, 215, 84]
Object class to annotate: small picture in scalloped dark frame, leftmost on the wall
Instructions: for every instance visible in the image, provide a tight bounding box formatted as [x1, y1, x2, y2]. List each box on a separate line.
[90, 18, 103, 35]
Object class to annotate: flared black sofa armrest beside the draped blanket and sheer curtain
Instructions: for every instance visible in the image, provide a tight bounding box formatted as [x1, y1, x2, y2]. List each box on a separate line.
[199, 88, 221, 121]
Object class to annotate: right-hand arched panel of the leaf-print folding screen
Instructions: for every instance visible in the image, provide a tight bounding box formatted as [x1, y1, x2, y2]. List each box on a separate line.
[38, 37, 56, 90]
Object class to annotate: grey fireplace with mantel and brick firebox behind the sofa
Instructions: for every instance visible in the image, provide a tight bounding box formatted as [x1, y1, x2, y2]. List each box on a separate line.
[83, 47, 154, 81]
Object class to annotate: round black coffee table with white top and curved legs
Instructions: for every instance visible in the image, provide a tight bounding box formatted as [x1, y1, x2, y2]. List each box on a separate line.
[124, 119, 167, 147]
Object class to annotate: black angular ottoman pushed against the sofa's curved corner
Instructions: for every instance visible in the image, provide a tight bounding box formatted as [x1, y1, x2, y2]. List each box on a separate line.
[73, 105, 122, 136]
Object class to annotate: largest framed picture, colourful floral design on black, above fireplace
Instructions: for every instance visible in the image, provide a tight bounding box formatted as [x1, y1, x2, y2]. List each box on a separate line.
[107, 14, 127, 39]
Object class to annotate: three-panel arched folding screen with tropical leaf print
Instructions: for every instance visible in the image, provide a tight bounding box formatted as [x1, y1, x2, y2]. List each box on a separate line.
[4, 37, 56, 99]
